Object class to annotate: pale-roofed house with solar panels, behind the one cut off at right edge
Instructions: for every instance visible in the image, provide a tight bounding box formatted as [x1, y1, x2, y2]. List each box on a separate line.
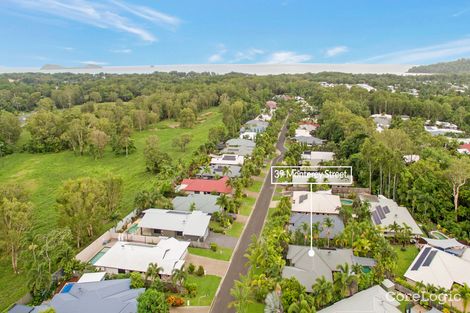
[359, 195, 423, 236]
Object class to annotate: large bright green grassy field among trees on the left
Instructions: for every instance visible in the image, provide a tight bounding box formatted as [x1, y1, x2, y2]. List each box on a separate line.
[0, 108, 221, 311]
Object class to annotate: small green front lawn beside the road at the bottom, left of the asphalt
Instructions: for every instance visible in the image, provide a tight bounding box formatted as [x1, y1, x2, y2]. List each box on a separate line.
[185, 275, 222, 306]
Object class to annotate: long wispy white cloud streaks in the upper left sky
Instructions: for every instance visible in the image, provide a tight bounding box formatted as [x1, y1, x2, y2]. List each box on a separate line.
[6, 0, 180, 42]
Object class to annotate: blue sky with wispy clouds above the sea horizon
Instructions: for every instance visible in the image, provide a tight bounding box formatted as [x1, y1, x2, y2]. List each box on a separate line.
[0, 0, 470, 67]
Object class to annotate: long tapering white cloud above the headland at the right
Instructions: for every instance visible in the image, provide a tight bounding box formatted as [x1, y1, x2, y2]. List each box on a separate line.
[362, 38, 470, 64]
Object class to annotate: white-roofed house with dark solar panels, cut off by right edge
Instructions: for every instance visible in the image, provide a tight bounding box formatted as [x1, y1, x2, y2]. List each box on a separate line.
[404, 245, 470, 290]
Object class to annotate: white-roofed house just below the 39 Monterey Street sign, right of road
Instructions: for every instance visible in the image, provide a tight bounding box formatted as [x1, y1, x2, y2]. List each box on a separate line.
[292, 191, 341, 214]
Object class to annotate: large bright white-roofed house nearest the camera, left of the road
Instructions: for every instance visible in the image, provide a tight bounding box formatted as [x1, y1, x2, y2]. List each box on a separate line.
[93, 238, 189, 276]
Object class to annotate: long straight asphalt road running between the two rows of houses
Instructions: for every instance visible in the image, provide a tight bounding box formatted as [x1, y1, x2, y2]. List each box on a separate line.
[210, 117, 287, 313]
